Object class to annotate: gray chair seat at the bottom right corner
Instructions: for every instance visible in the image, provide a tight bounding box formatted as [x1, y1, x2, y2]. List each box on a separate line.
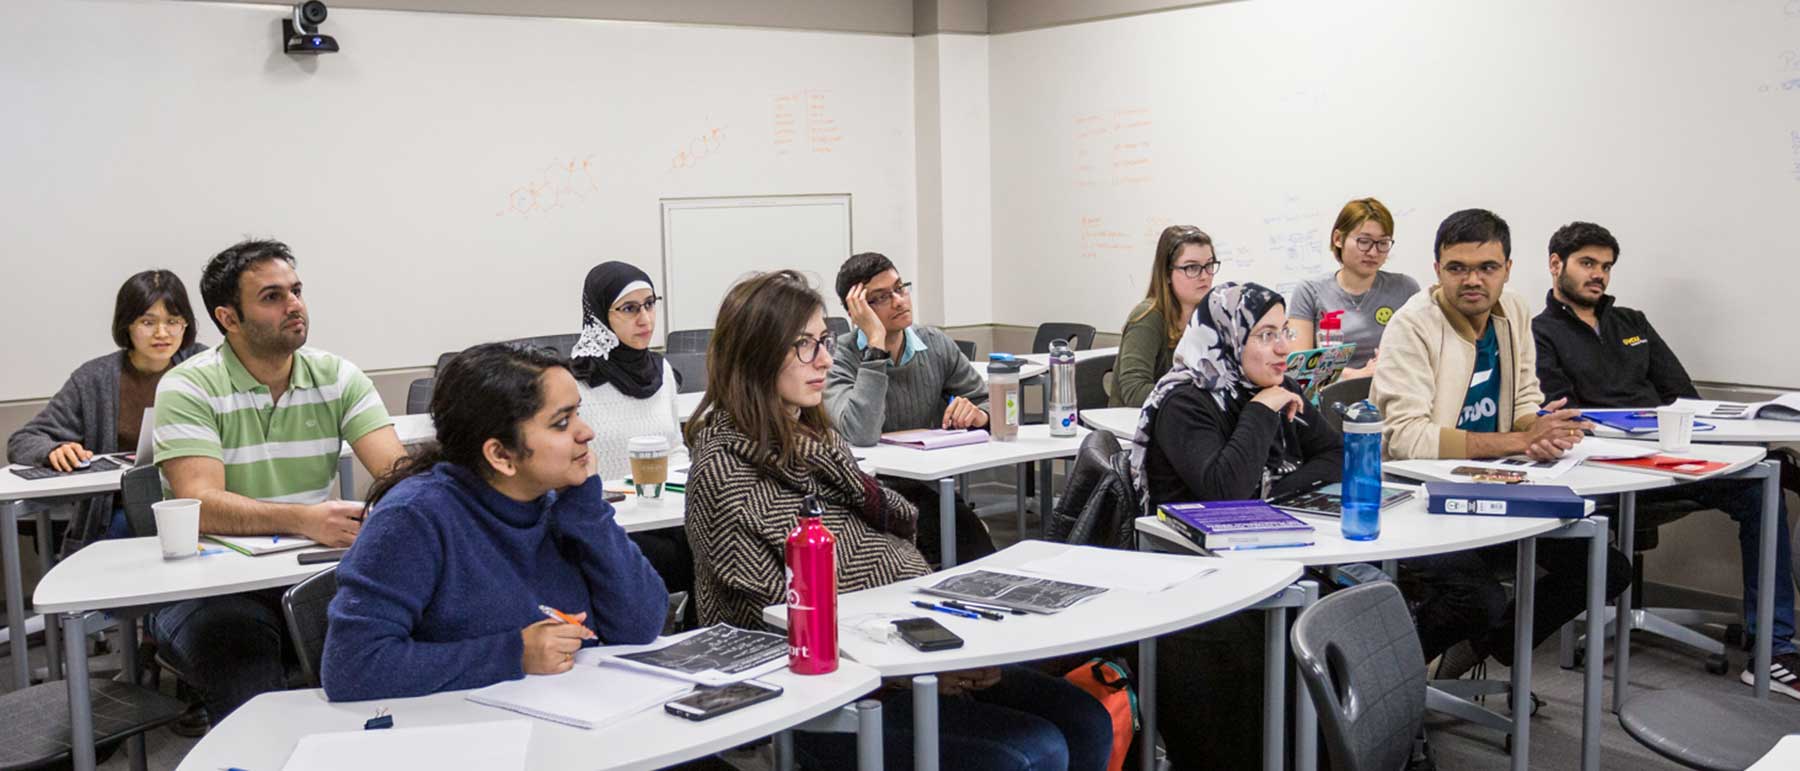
[1618, 690, 1800, 771]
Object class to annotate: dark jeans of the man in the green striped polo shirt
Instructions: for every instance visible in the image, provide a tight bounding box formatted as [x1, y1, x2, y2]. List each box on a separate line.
[149, 589, 299, 726]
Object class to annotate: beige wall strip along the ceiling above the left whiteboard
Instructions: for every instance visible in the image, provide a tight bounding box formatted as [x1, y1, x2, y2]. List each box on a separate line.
[182, 0, 914, 36]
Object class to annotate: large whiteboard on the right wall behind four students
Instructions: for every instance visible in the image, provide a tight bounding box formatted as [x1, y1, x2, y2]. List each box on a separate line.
[990, 0, 1800, 387]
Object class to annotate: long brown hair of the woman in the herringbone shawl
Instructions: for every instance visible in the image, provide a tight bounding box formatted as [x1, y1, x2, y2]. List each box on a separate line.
[688, 270, 832, 467]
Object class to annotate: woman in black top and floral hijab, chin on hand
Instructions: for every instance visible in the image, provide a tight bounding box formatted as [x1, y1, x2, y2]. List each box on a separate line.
[1130, 283, 1343, 506]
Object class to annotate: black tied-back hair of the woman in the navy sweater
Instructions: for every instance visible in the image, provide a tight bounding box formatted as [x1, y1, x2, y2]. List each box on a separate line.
[369, 342, 569, 508]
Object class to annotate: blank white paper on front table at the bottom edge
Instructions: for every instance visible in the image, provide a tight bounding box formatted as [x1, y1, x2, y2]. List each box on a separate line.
[283, 721, 531, 771]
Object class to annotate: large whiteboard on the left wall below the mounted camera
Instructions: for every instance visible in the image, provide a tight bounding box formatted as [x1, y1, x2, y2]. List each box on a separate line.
[0, 0, 918, 400]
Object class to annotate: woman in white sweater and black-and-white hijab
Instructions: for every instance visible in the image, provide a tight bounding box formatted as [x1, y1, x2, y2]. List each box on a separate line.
[571, 261, 682, 481]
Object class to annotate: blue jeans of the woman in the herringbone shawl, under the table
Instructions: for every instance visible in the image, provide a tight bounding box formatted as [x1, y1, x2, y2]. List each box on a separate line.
[794, 667, 1112, 771]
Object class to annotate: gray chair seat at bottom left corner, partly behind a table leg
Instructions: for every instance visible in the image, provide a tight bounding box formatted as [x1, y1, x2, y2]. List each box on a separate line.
[0, 679, 187, 769]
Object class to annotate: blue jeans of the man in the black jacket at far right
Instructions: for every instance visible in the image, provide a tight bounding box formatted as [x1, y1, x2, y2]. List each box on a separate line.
[1638, 479, 1796, 654]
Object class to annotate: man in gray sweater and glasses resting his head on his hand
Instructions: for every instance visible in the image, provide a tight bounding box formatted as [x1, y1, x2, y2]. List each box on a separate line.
[824, 252, 994, 562]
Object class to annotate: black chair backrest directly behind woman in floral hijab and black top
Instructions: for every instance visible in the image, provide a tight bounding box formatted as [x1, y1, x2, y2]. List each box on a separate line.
[1049, 431, 1139, 549]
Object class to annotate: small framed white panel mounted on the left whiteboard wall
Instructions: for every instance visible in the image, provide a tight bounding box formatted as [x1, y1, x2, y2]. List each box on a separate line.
[662, 193, 850, 331]
